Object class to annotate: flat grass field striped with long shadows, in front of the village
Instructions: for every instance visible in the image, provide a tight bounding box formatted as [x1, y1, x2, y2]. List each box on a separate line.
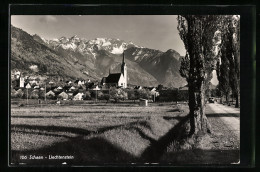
[10, 102, 188, 165]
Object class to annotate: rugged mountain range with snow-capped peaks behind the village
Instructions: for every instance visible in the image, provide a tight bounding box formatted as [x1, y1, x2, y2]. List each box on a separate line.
[11, 26, 186, 87]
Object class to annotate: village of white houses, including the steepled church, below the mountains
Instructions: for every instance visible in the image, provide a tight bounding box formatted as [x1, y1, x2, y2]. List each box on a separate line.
[11, 53, 188, 104]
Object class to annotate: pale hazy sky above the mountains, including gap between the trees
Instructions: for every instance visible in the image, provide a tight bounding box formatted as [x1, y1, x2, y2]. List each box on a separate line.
[11, 15, 217, 84]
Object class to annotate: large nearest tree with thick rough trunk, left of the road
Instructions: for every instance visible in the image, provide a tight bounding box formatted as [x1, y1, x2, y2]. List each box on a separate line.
[177, 15, 221, 134]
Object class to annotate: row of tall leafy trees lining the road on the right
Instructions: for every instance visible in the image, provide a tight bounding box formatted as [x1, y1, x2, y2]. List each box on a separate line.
[177, 15, 240, 134]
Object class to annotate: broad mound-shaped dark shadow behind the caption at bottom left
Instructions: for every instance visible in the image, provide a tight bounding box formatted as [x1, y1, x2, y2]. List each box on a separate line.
[11, 137, 136, 165]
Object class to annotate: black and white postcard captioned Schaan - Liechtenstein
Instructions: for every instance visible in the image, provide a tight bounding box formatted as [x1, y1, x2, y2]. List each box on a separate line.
[9, 6, 256, 166]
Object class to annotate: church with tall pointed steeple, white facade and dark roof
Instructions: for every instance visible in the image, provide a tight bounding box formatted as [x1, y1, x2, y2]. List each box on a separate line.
[101, 52, 127, 88]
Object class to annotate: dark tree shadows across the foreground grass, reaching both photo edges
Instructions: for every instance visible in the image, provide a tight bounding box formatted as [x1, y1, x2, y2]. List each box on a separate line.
[11, 113, 239, 165]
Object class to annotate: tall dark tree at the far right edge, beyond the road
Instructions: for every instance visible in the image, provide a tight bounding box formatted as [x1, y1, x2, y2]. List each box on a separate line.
[217, 15, 240, 107]
